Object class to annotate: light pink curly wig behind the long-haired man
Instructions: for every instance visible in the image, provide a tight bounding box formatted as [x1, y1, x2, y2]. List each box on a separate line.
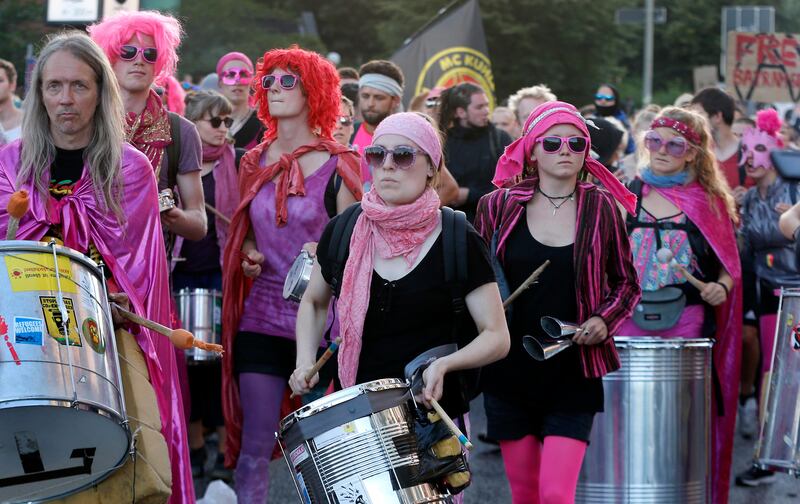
[87, 11, 183, 84]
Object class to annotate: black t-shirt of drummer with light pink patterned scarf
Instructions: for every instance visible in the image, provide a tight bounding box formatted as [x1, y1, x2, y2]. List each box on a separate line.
[317, 213, 495, 414]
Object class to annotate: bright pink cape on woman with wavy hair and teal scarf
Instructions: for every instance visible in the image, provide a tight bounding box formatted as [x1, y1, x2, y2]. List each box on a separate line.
[653, 182, 742, 504]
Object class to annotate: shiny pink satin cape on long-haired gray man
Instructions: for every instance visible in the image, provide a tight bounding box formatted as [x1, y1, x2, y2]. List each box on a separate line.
[0, 140, 195, 503]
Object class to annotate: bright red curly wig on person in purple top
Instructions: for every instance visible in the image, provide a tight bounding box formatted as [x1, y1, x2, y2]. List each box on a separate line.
[252, 45, 341, 140]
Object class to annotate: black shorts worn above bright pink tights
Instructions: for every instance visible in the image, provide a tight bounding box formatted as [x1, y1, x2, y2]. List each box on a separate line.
[483, 393, 595, 443]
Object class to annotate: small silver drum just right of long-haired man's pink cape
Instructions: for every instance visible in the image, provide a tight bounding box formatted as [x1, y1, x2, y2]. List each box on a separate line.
[176, 288, 222, 364]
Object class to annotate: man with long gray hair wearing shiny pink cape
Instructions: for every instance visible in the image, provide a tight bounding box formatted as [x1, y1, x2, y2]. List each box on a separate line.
[0, 31, 194, 502]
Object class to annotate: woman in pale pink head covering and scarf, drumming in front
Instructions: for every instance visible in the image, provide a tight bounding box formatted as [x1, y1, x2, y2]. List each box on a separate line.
[290, 112, 508, 417]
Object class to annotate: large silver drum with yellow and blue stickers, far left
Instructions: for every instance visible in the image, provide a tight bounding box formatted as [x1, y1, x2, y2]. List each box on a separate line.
[0, 241, 130, 502]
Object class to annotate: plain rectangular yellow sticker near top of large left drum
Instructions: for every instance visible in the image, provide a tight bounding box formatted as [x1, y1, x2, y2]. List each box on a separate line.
[5, 252, 78, 293]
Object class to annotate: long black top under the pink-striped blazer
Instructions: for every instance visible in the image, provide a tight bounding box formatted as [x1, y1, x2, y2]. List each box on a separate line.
[483, 219, 603, 412]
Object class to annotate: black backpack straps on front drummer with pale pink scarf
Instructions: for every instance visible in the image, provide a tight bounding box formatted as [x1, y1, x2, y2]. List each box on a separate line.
[328, 203, 480, 406]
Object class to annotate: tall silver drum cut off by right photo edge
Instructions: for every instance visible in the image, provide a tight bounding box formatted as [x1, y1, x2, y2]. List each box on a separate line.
[755, 289, 800, 476]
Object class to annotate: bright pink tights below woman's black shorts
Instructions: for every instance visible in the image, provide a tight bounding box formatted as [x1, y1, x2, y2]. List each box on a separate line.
[500, 436, 587, 504]
